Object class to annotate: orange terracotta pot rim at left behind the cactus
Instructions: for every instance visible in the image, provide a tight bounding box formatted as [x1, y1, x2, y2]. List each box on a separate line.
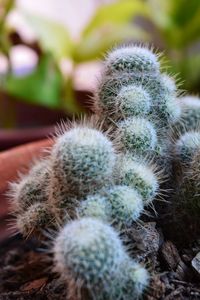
[0, 139, 53, 241]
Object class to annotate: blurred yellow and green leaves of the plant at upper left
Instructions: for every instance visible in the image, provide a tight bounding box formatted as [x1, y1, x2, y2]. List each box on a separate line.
[0, 0, 147, 126]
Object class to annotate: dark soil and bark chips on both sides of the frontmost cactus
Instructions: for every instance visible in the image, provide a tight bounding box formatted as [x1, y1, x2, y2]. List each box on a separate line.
[0, 222, 200, 300]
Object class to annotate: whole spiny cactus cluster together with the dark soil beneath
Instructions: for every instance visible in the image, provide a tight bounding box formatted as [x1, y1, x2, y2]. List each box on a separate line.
[0, 46, 200, 300]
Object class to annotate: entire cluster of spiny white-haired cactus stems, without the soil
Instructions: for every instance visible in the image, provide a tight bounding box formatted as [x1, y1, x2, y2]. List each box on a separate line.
[11, 46, 200, 300]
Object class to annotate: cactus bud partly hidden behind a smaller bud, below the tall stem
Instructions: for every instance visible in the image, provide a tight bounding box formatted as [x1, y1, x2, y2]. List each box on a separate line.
[116, 155, 159, 205]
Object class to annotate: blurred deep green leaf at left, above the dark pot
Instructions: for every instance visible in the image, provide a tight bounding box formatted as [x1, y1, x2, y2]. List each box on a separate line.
[5, 54, 62, 108]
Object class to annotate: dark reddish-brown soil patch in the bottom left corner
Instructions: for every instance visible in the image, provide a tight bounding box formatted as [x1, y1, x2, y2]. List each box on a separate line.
[0, 237, 66, 300]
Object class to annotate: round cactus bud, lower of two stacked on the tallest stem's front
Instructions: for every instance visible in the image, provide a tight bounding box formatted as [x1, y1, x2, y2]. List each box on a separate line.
[117, 117, 157, 155]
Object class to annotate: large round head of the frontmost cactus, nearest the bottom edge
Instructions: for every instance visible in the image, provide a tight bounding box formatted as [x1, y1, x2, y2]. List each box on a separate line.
[53, 218, 126, 299]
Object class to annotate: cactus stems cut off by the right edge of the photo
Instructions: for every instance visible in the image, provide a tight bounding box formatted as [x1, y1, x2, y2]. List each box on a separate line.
[173, 96, 200, 220]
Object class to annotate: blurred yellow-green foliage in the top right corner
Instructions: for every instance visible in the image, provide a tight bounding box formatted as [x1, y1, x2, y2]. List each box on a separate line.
[146, 0, 200, 92]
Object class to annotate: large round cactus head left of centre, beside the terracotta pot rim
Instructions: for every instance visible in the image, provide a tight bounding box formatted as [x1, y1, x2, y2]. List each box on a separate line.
[50, 126, 116, 206]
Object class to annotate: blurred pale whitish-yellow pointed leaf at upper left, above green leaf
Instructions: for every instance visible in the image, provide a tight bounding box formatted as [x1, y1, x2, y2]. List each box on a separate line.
[22, 12, 72, 60]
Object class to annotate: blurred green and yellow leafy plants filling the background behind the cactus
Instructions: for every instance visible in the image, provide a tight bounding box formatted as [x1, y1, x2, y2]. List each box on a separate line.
[0, 0, 200, 128]
